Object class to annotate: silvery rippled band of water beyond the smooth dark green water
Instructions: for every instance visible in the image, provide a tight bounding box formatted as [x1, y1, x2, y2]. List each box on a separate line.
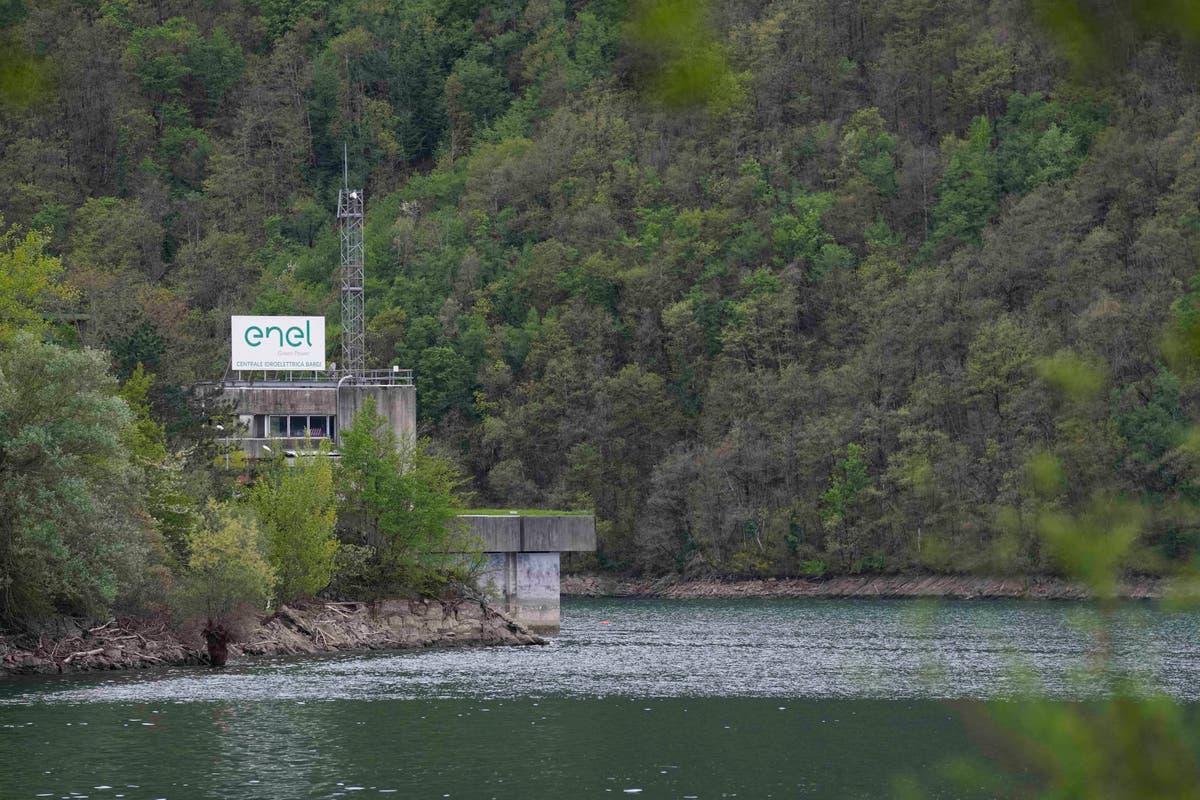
[0, 600, 1200, 705]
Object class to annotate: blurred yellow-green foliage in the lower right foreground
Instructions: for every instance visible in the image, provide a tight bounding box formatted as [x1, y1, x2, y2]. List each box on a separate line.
[926, 338, 1200, 800]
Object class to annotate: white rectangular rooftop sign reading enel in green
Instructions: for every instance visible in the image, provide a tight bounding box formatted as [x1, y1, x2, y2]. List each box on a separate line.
[232, 317, 325, 369]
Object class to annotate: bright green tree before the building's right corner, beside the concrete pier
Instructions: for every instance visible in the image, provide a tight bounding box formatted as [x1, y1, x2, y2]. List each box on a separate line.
[337, 401, 464, 596]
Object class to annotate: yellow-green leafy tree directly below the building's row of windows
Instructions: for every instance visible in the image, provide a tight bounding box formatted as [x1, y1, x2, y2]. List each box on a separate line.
[250, 443, 337, 602]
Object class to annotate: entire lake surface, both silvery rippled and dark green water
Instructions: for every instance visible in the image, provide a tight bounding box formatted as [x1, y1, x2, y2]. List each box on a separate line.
[0, 600, 1200, 800]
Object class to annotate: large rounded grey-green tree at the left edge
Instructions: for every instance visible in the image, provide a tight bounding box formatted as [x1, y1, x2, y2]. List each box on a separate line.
[0, 333, 158, 621]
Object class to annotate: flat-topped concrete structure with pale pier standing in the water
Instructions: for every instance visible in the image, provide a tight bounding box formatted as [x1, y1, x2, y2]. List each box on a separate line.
[461, 515, 596, 633]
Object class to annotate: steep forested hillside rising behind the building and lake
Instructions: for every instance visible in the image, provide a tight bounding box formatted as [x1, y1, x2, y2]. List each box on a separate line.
[0, 0, 1200, 575]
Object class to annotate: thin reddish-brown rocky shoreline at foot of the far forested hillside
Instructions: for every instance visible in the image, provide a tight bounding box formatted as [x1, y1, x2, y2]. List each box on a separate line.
[562, 575, 1164, 600]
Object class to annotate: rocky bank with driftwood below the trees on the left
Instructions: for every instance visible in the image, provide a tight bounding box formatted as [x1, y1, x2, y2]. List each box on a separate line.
[0, 599, 545, 675]
